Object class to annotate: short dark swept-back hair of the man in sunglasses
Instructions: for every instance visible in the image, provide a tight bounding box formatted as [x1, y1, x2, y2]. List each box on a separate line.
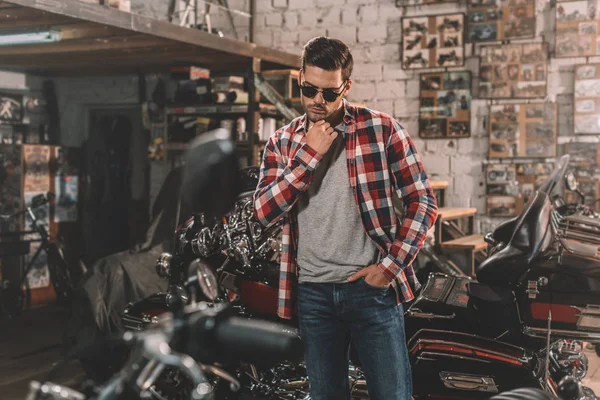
[302, 36, 354, 80]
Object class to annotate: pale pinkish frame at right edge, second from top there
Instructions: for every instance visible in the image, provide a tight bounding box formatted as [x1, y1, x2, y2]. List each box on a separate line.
[573, 64, 600, 134]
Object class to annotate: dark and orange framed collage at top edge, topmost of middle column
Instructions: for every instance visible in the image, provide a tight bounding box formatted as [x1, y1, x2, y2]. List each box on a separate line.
[467, 0, 535, 42]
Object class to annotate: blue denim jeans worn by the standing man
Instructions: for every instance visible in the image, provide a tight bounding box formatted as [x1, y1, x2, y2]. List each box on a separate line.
[298, 278, 412, 400]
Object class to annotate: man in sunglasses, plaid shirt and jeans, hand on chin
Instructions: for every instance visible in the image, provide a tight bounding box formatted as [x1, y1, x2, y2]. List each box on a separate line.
[254, 37, 437, 400]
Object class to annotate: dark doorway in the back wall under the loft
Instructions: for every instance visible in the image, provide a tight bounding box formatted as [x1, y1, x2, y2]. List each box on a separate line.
[83, 106, 149, 265]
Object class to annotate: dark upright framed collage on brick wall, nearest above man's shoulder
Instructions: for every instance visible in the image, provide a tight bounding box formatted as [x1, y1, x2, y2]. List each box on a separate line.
[419, 71, 471, 139]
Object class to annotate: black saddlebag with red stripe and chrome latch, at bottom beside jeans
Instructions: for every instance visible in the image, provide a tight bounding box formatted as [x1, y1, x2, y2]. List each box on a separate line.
[408, 329, 541, 399]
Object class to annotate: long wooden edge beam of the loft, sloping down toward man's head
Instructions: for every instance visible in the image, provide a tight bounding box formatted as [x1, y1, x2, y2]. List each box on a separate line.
[5, 0, 300, 68]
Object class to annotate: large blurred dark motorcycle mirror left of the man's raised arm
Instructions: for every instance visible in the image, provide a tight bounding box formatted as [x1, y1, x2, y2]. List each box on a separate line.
[181, 129, 240, 217]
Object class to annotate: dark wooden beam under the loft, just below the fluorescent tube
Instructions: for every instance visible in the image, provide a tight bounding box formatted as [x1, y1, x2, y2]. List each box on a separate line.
[0, 35, 173, 56]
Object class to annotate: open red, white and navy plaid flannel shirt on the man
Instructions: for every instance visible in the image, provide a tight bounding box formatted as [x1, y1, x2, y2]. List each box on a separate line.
[254, 100, 437, 319]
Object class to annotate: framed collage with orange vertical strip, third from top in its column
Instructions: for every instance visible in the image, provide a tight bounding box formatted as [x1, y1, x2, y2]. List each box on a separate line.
[489, 103, 557, 158]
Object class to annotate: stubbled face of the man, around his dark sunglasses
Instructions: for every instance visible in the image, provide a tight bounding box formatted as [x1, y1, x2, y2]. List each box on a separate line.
[298, 65, 352, 123]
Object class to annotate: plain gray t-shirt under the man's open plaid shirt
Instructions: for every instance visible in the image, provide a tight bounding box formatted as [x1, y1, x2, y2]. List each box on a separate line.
[297, 123, 378, 283]
